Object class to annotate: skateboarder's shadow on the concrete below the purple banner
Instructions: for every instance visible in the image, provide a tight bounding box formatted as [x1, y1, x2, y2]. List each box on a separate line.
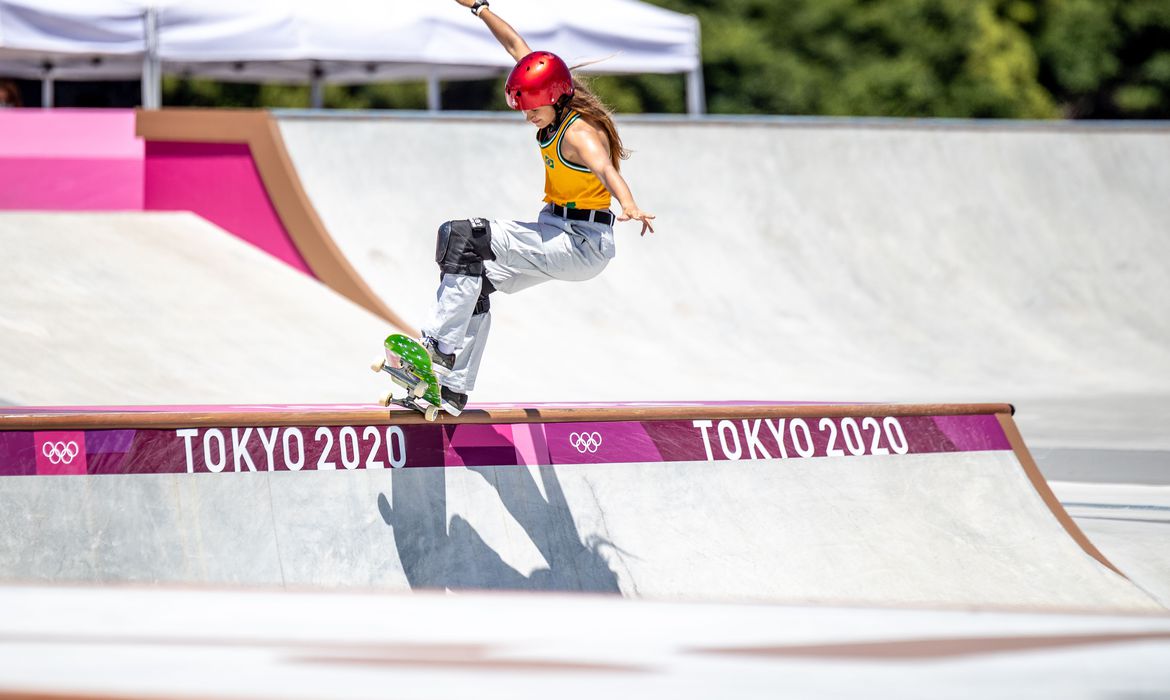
[378, 467, 620, 593]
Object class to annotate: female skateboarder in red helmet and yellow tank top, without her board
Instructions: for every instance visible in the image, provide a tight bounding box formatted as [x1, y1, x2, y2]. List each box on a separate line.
[421, 0, 654, 416]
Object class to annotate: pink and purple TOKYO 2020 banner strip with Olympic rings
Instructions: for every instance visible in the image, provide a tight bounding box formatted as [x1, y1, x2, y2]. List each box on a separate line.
[0, 414, 1011, 475]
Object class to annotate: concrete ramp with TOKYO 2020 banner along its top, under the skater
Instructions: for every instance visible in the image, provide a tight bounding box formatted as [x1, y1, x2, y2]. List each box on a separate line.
[0, 405, 1161, 611]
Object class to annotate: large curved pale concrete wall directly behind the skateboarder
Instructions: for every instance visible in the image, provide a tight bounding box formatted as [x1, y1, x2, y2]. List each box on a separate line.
[280, 114, 1170, 449]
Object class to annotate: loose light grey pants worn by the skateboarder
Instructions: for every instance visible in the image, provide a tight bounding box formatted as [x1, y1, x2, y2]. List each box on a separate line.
[422, 207, 614, 393]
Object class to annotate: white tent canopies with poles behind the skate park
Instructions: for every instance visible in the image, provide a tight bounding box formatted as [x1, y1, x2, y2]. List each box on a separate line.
[0, 0, 702, 112]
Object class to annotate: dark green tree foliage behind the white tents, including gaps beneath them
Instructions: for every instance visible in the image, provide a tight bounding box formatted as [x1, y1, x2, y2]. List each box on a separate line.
[164, 0, 1170, 118]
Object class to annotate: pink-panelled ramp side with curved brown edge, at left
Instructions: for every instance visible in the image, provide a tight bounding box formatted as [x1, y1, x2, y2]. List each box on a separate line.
[0, 110, 414, 332]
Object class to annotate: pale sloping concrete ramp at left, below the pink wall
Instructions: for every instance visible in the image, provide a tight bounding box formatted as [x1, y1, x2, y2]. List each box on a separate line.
[0, 212, 394, 405]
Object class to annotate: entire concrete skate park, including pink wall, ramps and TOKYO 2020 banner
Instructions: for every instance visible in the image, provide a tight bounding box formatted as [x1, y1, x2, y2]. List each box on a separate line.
[0, 110, 1170, 698]
